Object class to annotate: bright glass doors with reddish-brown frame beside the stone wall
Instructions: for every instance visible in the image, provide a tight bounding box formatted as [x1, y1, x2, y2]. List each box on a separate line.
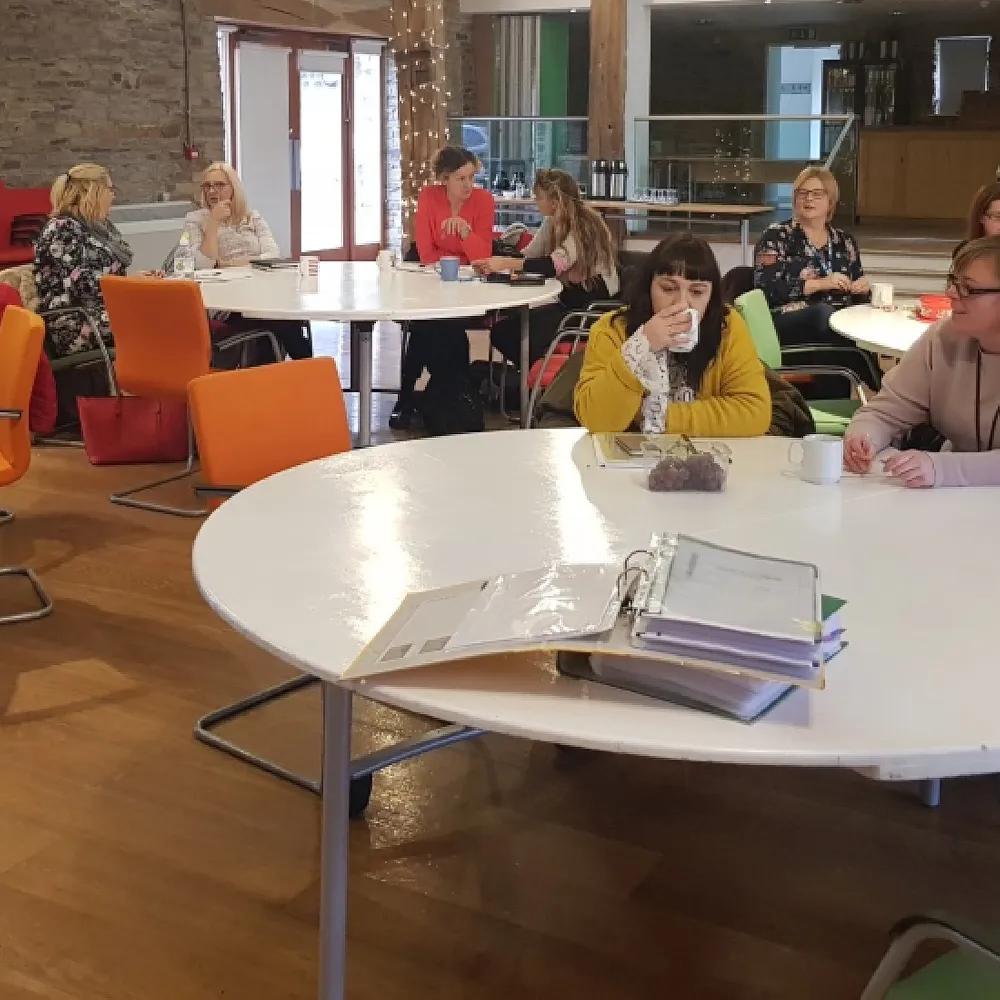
[223, 29, 385, 260]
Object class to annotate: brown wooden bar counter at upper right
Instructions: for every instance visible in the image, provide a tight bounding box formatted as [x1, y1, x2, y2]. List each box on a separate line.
[858, 128, 1000, 219]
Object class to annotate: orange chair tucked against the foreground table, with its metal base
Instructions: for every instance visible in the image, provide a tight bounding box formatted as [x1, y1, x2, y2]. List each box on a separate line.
[188, 358, 372, 816]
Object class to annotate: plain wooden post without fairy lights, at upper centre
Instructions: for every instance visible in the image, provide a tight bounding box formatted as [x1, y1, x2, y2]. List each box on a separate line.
[588, 0, 628, 160]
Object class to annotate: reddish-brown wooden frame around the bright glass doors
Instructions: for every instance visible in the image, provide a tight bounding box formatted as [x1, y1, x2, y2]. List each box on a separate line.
[219, 21, 388, 260]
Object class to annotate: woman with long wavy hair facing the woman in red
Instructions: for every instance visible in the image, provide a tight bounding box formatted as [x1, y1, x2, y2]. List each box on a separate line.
[477, 169, 619, 367]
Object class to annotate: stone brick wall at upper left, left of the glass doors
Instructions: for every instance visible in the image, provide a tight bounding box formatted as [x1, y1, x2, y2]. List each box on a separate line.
[0, 0, 222, 202]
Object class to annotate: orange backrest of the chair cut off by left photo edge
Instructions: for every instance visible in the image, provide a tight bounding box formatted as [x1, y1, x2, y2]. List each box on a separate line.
[0, 306, 45, 486]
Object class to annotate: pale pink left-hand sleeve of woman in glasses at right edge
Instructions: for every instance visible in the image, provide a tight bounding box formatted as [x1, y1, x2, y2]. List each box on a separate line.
[847, 327, 935, 451]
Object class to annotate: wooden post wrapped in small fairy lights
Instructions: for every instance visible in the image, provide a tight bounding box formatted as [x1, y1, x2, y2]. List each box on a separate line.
[390, 0, 448, 241]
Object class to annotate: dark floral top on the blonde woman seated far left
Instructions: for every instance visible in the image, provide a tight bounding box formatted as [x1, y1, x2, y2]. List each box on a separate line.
[35, 215, 132, 358]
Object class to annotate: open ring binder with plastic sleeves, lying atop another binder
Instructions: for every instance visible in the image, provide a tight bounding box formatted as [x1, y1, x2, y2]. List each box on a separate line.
[343, 535, 842, 708]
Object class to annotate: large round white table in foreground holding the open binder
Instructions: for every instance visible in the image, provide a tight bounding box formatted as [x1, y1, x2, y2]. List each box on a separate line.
[194, 430, 1000, 1000]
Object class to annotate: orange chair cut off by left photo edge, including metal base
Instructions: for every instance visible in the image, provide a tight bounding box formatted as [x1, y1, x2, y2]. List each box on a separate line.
[0, 306, 52, 625]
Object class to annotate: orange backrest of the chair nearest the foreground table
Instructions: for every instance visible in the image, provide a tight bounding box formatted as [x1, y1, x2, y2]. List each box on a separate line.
[188, 358, 351, 496]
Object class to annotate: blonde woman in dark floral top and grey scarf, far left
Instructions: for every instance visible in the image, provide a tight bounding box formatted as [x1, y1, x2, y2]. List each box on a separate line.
[35, 163, 132, 358]
